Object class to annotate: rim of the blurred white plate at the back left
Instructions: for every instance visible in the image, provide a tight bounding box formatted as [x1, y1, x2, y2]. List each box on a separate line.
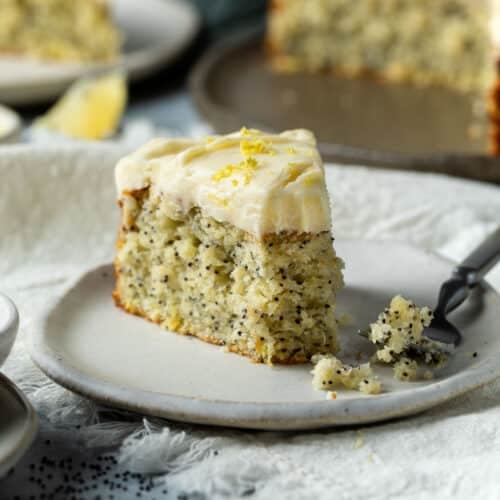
[0, 0, 201, 106]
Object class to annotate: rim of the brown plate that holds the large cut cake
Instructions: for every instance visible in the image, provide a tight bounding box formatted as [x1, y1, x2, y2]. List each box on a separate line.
[188, 25, 500, 184]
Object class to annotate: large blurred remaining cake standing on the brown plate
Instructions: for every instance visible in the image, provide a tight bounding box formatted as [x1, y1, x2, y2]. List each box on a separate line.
[267, 0, 500, 154]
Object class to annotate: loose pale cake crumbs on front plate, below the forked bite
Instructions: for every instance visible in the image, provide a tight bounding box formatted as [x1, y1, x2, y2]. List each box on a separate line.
[311, 354, 382, 394]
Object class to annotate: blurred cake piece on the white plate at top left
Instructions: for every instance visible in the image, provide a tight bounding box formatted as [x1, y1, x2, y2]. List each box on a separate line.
[0, 0, 121, 61]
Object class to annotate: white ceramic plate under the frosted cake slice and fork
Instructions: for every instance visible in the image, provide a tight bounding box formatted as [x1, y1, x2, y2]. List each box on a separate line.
[30, 241, 500, 429]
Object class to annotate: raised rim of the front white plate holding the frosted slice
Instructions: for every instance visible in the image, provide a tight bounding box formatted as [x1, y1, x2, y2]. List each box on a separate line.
[28, 239, 500, 430]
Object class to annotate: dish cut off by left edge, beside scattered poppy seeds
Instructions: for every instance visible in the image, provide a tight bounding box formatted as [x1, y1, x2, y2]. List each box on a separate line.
[0, 373, 38, 478]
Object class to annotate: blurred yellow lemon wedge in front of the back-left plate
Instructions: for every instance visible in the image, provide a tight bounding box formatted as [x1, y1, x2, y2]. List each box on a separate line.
[35, 71, 127, 140]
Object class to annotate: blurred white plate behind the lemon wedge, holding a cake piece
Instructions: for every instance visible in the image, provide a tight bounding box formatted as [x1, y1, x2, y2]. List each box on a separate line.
[0, 0, 200, 104]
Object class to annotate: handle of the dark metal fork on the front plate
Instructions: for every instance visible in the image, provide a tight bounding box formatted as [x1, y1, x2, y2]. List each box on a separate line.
[434, 227, 500, 316]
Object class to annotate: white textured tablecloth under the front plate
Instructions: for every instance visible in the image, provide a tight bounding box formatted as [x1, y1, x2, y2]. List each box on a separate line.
[0, 138, 500, 500]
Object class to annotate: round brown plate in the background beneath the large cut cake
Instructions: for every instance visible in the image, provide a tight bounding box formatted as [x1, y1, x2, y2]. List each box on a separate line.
[190, 29, 500, 183]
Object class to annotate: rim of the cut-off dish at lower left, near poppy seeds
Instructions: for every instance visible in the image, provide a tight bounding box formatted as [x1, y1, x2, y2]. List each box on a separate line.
[0, 372, 39, 479]
